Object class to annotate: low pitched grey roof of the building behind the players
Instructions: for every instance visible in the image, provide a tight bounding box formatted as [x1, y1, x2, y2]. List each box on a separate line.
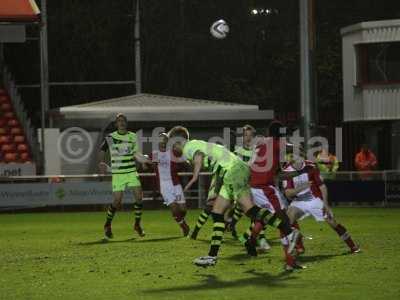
[58, 94, 274, 122]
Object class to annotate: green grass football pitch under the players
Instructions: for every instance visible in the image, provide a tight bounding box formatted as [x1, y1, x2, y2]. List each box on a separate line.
[0, 208, 400, 300]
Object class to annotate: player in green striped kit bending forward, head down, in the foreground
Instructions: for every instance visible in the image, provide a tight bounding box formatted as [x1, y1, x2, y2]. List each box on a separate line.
[168, 126, 299, 267]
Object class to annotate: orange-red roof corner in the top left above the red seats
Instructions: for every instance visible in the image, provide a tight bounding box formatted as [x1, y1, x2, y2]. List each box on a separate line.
[0, 0, 40, 22]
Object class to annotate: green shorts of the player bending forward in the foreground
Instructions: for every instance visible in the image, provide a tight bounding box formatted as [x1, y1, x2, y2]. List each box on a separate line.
[216, 161, 251, 202]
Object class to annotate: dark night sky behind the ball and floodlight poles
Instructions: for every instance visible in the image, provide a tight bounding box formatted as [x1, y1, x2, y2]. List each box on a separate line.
[5, 0, 400, 126]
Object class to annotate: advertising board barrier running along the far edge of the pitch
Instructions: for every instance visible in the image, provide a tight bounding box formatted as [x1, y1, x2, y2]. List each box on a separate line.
[0, 170, 400, 210]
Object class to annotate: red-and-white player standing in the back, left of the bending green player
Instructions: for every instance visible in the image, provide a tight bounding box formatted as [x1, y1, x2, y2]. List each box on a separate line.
[151, 133, 190, 236]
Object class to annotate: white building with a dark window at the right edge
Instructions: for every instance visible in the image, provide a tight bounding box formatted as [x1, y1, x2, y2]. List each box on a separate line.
[341, 19, 400, 168]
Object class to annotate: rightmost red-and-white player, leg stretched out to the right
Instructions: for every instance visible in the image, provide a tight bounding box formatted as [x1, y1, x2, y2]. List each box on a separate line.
[282, 155, 360, 254]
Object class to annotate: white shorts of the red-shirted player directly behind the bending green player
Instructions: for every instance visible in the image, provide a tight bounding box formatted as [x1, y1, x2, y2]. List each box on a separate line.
[251, 185, 287, 213]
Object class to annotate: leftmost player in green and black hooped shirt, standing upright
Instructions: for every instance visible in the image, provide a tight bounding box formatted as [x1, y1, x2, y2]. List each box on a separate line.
[99, 113, 151, 240]
